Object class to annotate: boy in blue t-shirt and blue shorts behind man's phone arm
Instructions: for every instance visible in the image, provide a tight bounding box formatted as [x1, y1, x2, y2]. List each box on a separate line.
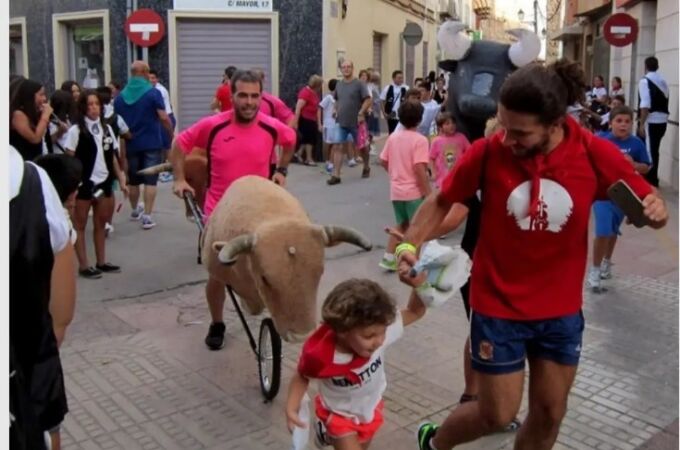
[587, 106, 652, 293]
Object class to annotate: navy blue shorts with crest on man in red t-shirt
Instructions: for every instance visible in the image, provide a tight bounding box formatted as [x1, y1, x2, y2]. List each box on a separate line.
[470, 311, 585, 374]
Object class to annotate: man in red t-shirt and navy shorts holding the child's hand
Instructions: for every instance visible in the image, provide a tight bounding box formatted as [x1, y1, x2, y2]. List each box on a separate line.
[396, 61, 668, 450]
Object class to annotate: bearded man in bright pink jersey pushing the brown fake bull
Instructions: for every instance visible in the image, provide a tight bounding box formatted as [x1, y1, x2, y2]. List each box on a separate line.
[171, 71, 296, 350]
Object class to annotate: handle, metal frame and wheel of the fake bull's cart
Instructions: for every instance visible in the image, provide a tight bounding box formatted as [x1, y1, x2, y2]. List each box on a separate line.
[184, 192, 281, 402]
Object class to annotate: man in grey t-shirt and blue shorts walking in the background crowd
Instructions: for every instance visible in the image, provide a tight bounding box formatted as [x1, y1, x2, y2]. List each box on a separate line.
[326, 60, 371, 186]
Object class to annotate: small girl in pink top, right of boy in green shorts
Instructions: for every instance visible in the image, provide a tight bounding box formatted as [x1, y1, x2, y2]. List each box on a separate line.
[430, 112, 470, 189]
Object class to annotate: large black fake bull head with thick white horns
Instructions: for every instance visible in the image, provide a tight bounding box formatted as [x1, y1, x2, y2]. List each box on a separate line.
[437, 21, 541, 140]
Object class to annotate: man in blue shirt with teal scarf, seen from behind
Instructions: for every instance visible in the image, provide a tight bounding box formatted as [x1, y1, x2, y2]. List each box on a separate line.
[113, 61, 174, 230]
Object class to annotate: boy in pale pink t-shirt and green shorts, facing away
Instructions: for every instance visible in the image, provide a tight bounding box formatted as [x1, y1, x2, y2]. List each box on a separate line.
[379, 102, 432, 272]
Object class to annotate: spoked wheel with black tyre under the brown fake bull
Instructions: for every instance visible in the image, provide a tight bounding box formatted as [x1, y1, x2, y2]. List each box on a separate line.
[257, 318, 281, 400]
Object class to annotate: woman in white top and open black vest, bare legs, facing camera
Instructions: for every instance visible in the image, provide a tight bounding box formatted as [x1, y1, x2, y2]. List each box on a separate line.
[66, 90, 127, 278]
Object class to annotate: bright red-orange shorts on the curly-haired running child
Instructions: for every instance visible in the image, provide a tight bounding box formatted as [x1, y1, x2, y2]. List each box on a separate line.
[314, 395, 384, 445]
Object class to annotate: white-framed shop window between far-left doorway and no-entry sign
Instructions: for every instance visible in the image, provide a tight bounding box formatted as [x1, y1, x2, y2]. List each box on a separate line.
[53, 10, 110, 89]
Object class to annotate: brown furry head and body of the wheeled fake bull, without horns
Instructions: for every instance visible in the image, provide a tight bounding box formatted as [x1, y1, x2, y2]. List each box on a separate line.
[201, 176, 350, 340]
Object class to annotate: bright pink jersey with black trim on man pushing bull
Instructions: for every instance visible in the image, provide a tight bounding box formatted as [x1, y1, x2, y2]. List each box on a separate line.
[177, 110, 296, 217]
